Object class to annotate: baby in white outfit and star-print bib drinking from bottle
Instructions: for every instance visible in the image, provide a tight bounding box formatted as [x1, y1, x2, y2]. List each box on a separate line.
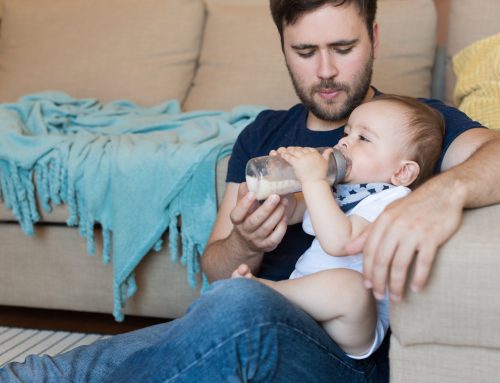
[232, 95, 444, 359]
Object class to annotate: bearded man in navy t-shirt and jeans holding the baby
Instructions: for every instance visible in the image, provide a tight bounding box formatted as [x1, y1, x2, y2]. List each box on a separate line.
[0, 0, 500, 382]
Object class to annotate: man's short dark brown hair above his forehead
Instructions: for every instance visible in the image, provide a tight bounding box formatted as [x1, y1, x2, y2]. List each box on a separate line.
[270, 0, 377, 46]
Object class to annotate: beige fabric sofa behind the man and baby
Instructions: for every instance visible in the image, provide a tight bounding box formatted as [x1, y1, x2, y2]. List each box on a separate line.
[0, 0, 500, 382]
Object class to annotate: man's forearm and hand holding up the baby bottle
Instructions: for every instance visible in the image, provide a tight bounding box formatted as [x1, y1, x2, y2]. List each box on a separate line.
[201, 183, 287, 281]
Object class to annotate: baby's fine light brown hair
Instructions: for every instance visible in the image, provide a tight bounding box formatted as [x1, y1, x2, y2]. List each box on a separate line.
[369, 94, 445, 189]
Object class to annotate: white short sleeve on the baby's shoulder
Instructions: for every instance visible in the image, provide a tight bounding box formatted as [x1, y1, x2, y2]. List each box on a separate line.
[348, 186, 410, 222]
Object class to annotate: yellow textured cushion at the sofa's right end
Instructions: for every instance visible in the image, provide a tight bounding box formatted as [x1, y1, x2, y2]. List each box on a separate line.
[453, 33, 500, 130]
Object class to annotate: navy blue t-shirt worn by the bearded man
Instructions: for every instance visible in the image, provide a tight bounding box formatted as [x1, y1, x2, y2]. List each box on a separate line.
[226, 99, 481, 280]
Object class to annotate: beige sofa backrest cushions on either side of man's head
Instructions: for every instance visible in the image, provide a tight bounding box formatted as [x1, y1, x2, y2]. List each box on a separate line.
[0, 0, 438, 110]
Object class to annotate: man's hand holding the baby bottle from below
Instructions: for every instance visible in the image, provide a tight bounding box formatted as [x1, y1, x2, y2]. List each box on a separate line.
[230, 183, 288, 253]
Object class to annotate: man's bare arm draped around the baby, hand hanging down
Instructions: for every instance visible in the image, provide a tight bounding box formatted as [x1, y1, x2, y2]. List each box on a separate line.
[347, 128, 500, 300]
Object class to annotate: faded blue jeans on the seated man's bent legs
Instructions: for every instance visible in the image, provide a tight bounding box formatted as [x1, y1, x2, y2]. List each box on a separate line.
[0, 278, 389, 383]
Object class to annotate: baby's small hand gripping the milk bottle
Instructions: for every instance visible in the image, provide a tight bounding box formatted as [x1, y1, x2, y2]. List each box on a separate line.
[278, 146, 331, 184]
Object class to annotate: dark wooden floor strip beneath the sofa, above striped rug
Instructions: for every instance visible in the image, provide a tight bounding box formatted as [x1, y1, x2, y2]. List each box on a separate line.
[0, 306, 168, 334]
